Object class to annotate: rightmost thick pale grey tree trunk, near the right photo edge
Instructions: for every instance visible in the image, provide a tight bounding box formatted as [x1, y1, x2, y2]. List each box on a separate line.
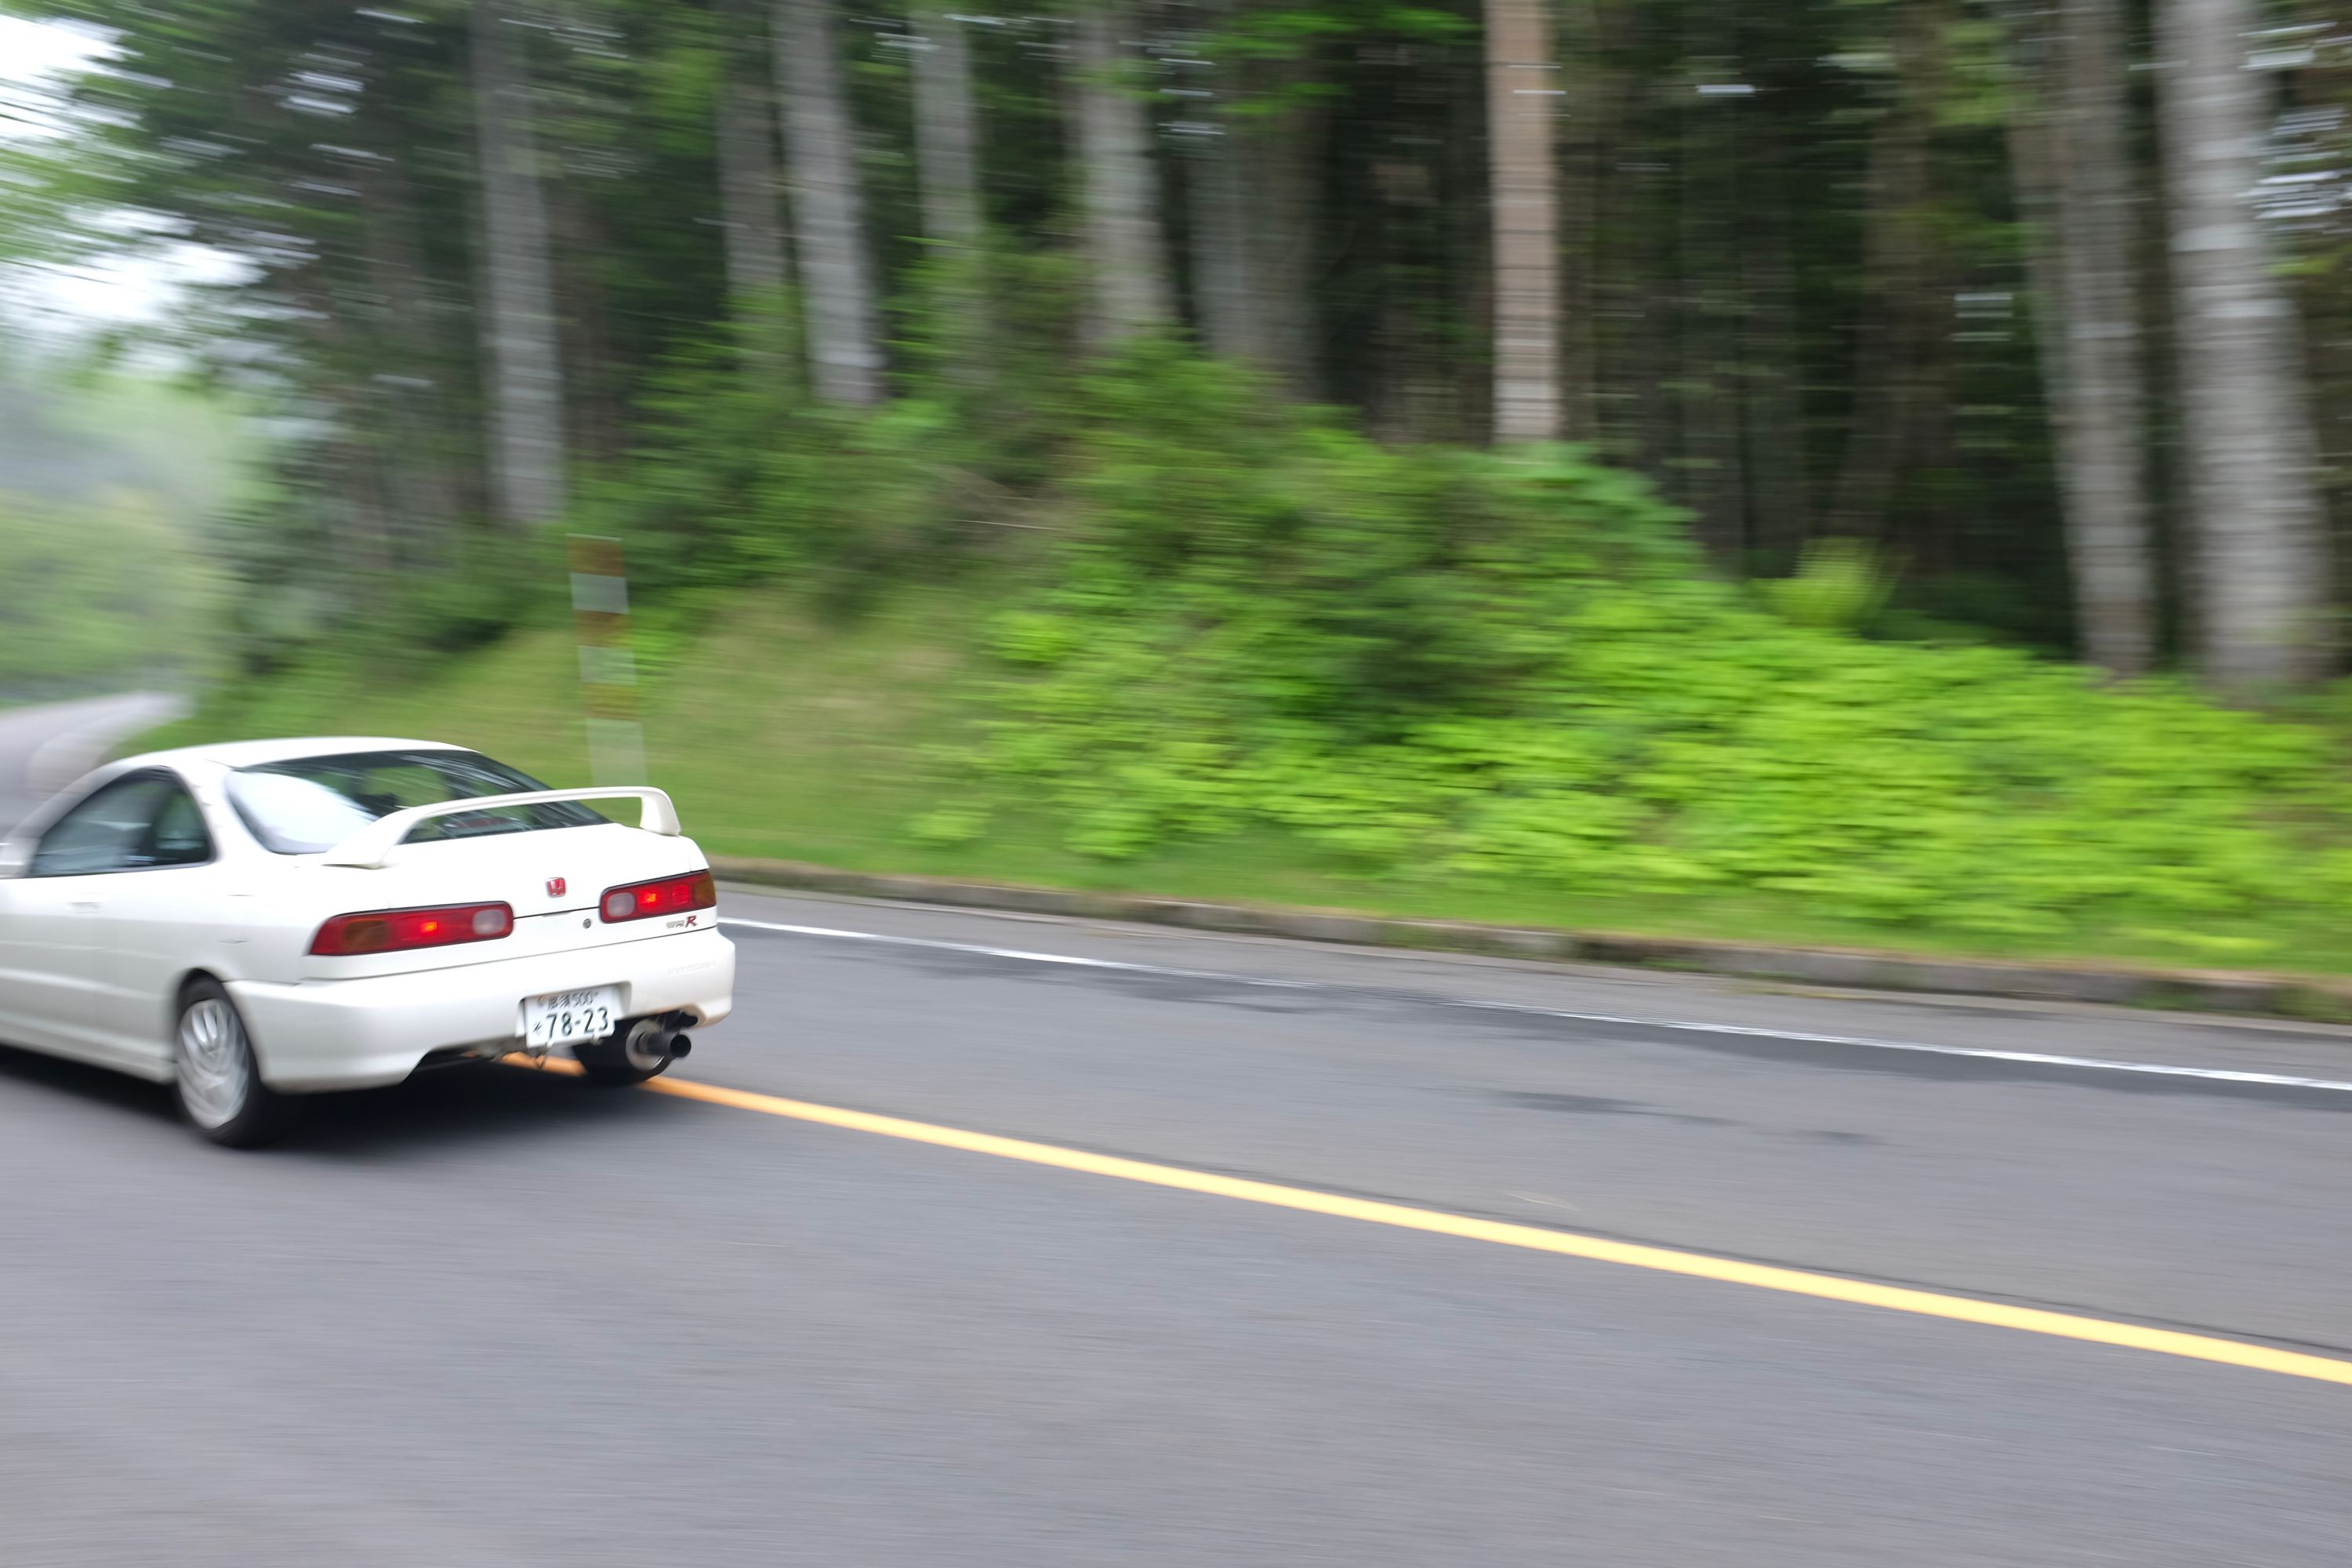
[2157, 0, 2336, 694]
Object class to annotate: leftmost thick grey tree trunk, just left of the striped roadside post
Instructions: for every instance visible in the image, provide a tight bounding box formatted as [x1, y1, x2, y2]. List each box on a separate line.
[473, 0, 564, 527]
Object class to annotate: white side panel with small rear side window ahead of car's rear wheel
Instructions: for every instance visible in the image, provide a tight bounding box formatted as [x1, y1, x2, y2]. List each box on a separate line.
[96, 774, 236, 1076]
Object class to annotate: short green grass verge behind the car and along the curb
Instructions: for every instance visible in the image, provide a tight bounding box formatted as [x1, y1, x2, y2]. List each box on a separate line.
[136, 586, 2352, 975]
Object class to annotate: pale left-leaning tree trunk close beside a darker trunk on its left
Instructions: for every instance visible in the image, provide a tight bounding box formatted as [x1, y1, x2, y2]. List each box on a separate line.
[776, 0, 882, 407]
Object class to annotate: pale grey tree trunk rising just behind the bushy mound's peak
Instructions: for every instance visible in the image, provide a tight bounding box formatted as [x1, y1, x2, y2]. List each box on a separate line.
[1073, 0, 1174, 348]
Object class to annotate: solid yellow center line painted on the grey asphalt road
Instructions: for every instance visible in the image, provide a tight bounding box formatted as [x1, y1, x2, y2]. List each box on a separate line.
[515, 1058, 2352, 1385]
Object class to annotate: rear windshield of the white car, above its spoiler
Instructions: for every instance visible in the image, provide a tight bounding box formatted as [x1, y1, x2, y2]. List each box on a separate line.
[228, 753, 607, 855]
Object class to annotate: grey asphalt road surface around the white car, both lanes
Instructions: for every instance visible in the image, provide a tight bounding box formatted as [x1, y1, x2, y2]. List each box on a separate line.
[0, 705, 2352, 1568]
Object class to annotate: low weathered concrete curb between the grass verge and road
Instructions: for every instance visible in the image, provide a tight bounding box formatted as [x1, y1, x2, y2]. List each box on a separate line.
[710, 855, 2352, 1022]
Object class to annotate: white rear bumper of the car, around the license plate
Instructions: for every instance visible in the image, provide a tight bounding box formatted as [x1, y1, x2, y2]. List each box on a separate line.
[228, 931, 734, 1093]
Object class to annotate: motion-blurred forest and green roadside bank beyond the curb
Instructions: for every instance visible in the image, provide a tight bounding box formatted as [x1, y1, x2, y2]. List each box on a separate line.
[0, 0, 2352, 968]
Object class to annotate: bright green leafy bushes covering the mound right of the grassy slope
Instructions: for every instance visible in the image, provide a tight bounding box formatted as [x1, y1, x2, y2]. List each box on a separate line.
[941, 350, 2352, 954]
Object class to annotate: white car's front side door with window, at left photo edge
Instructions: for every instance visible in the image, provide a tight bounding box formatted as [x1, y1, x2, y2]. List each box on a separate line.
[0, 771, 176, 1065]
